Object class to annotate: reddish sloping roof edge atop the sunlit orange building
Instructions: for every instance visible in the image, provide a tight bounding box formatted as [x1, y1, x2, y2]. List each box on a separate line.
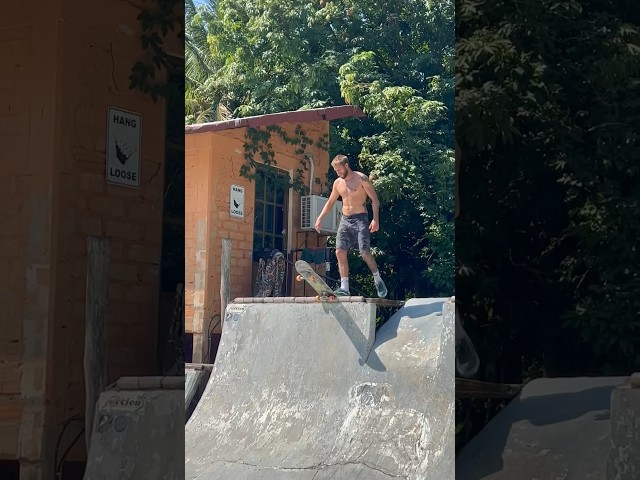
[184, 105, 366, 135]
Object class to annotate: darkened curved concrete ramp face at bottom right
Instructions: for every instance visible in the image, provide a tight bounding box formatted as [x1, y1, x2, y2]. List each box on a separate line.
[456, 377, 637, 480]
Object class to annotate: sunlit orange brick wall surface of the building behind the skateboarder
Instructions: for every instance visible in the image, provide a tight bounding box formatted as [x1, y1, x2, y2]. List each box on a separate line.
[185, 122, 329, 349]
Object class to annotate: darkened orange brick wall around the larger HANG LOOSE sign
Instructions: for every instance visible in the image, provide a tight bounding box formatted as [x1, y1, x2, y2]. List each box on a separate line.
[53, 0, 179, 459]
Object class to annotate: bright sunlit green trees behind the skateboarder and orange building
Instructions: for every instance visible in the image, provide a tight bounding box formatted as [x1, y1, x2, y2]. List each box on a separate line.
[187, 0, 454, 297]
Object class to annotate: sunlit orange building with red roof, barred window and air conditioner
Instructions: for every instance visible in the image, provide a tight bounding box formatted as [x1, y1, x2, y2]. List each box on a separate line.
[185, 106, 364, 363]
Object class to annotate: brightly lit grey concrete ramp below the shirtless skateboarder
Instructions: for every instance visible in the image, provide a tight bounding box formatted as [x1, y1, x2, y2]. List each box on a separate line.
[185, 298, 455, 480]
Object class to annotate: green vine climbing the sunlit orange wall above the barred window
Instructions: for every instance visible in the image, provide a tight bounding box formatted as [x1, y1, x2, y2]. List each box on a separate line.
[240, 125, 329, 195]
